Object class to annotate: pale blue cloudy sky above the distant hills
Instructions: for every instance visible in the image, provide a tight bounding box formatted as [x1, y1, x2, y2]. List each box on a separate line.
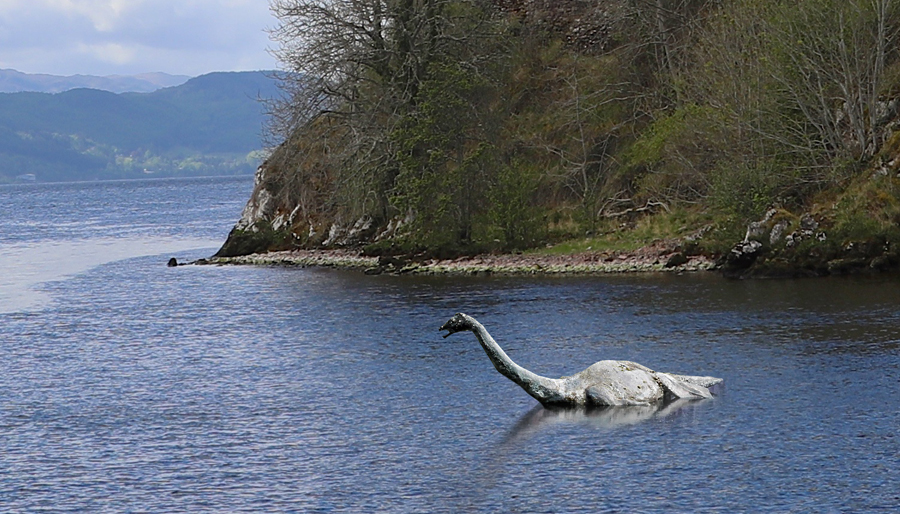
[0, 0, 277, 76]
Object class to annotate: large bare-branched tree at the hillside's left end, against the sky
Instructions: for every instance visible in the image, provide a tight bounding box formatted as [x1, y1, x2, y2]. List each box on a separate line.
[271, 0, 506, 222]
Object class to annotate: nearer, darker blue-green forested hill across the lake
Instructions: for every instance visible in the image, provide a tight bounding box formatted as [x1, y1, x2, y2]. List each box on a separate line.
[0, 72, 279, 182]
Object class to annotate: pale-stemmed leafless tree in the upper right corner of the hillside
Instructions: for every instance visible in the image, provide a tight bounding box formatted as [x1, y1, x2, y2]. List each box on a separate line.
[772, 0, 900, 159]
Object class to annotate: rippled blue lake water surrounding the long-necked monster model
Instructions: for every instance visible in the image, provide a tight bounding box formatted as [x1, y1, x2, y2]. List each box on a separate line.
[0, 175, 900, 513]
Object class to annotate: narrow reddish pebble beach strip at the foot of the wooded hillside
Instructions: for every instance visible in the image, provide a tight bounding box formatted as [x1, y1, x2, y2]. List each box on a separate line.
[194, 246, 716, 275]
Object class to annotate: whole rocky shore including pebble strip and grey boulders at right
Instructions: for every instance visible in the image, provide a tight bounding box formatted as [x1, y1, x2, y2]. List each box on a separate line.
[204, 204, 900, 278]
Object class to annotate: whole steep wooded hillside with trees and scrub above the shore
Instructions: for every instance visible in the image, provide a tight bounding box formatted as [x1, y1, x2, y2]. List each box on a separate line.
[223, 0, 900, 272]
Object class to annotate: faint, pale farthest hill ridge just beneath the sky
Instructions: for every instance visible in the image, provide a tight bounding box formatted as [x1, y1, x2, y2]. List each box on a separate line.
[0, 70, 190, 93]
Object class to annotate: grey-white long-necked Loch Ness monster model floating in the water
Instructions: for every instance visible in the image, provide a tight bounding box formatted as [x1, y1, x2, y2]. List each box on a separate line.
[439, 313, 722, 407]
